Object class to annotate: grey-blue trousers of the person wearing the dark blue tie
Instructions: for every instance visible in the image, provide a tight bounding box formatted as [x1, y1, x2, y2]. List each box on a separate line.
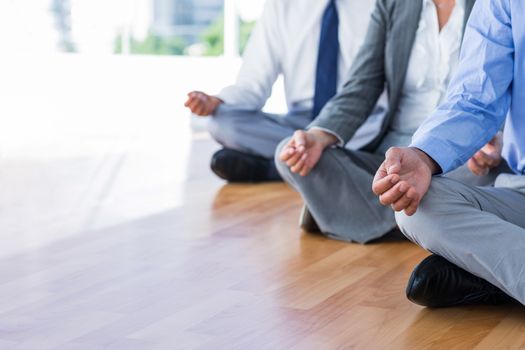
[208, 104, 385, 159]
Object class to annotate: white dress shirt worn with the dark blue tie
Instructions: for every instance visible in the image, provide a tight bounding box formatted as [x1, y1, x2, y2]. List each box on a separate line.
[216, 0, 375, 109]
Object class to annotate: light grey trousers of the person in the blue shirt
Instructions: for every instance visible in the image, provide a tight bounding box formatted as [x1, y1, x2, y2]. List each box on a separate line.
[396, 174, 525, 304]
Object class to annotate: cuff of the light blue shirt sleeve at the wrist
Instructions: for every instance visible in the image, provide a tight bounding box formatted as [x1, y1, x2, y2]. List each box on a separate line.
[410, 136, 462, 174]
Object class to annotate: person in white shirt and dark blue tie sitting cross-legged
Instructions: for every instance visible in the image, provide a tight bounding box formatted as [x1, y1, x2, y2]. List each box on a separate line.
[185, 0, 384, 182]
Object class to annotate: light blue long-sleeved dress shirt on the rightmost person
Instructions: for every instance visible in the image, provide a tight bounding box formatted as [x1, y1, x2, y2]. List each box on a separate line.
[411, 0, 525, 174]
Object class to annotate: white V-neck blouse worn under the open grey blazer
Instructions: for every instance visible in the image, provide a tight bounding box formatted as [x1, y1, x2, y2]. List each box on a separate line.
[390, 0, 465, 137]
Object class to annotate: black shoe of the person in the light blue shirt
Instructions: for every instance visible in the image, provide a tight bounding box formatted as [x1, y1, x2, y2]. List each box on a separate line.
[406, 255, 516, 307]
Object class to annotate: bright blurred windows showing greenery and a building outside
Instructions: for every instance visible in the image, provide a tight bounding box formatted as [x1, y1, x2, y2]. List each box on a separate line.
[0, 0, 263, 56]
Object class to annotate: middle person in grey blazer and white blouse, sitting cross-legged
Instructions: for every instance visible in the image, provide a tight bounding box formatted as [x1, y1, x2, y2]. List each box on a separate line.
[276, 0, 505, 243]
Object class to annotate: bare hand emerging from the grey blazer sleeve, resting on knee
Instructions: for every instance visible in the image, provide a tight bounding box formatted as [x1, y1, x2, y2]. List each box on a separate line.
[279, 129, 337, 176]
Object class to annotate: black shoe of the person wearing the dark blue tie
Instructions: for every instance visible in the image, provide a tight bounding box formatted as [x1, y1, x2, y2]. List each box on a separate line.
[210, 148, 281, 182]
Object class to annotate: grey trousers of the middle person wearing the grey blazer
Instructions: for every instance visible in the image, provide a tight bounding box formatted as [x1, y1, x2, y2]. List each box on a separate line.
[276, 140, 506, 243]
